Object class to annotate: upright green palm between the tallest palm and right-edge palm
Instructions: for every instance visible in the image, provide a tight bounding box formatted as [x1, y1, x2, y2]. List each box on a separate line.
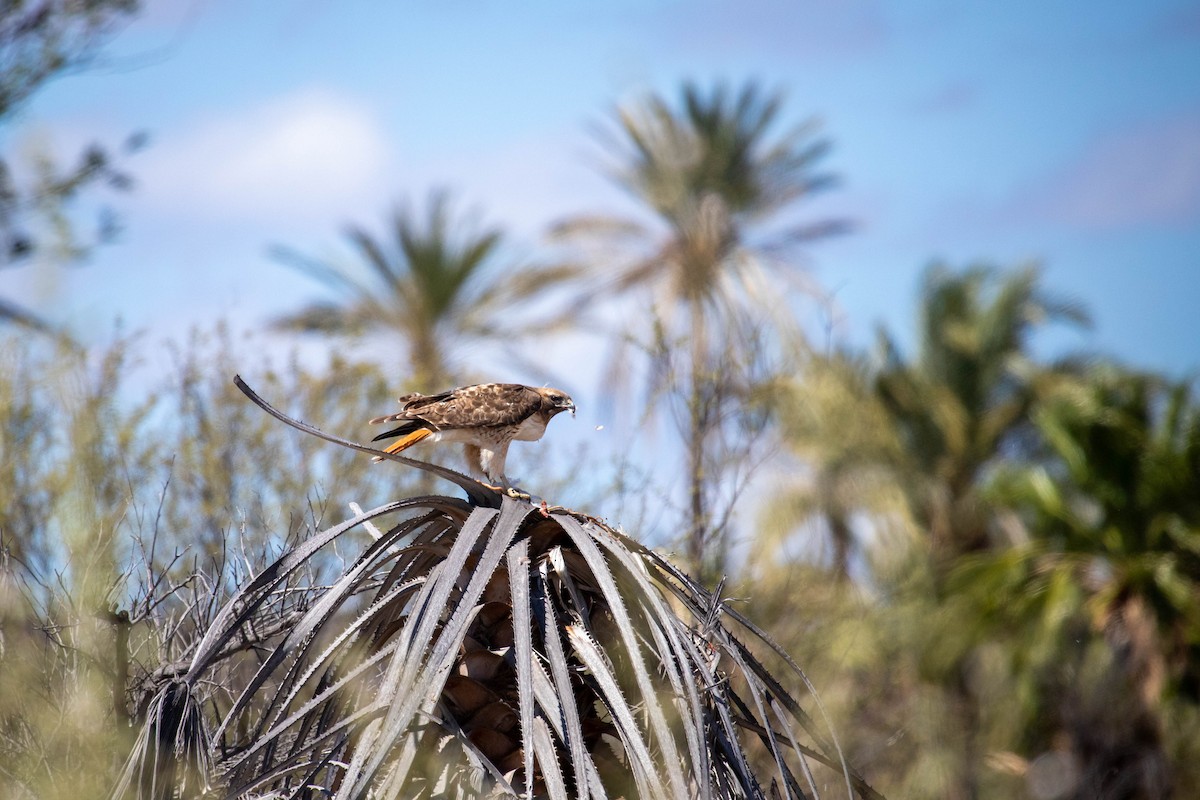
[874, 264, 1087, 564]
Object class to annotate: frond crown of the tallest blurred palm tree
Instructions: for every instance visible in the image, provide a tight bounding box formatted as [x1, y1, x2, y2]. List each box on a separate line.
[573, 82, 845, 309]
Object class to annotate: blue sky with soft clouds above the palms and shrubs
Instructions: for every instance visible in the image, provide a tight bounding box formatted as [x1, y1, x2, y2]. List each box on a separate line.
[9, 0, 1200, 390]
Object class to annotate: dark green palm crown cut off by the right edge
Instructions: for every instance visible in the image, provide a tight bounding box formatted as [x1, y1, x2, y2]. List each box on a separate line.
[1008, 367, 1200, 705]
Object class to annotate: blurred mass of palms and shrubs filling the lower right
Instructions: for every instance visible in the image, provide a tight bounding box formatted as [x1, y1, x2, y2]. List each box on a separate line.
[748, 267, 1200, 799]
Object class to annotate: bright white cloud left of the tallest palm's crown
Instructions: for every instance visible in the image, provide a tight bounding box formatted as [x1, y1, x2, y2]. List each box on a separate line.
[137, 90, 391, 230]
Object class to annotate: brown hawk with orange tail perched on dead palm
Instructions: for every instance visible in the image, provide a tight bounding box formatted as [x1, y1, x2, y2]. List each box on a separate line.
[371, 384, 575, 488]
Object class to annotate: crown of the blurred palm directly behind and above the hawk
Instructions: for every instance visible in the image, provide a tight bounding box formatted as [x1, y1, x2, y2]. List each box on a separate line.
[275, 191, 577, 391]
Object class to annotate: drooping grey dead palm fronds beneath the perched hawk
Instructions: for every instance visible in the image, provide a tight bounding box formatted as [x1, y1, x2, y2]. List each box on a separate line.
[114, 378, 880, 799]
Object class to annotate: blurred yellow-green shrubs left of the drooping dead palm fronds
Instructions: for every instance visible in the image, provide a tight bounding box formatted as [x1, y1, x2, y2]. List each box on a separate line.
[0, 333, 412, 798]
